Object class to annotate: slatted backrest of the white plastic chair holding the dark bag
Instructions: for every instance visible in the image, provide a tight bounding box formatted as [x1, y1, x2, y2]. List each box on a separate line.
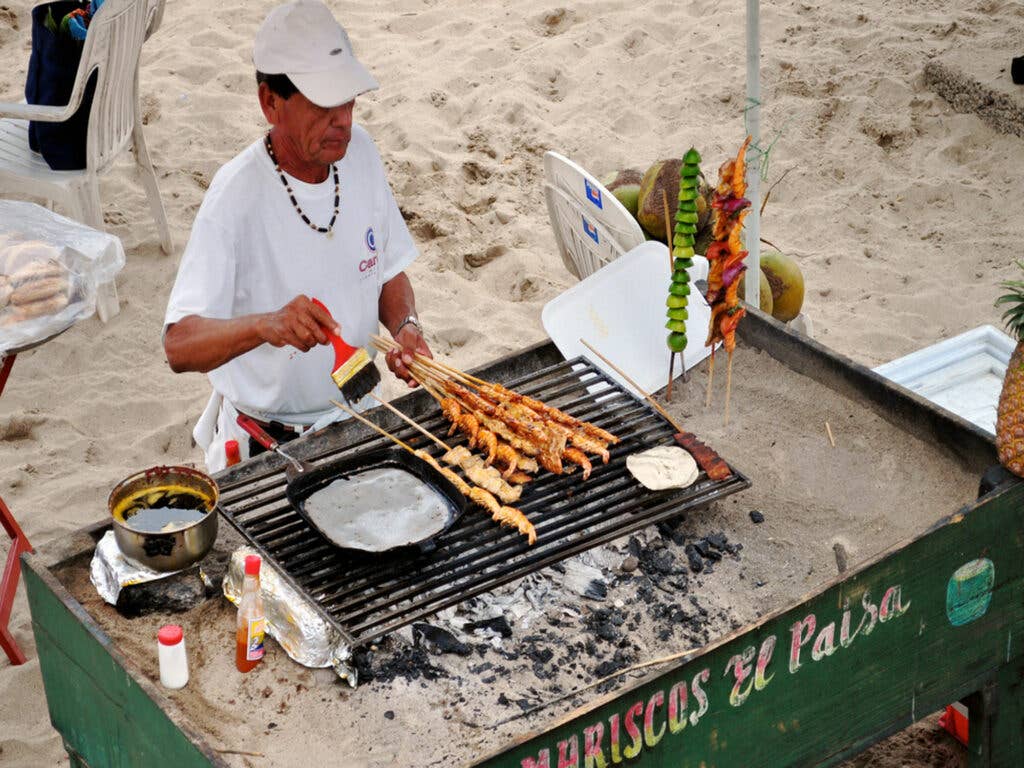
[79, 0, 151, 173]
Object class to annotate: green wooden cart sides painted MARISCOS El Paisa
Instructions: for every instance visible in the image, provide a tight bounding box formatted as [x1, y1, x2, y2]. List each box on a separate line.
[23, 312, 1024, 768]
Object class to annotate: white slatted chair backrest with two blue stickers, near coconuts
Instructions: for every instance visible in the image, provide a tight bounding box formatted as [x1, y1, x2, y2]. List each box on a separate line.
[544, 152, 646, 279]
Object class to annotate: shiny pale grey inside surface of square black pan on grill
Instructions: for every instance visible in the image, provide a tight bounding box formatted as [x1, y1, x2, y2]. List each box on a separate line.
[304, 469, 451, 552]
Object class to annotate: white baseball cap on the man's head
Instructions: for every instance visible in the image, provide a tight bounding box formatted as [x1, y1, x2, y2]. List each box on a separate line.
[253, 0, 379, 106]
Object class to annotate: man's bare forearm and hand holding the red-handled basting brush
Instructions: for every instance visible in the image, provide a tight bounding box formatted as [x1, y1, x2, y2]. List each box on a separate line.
[164, 296, 339, 373]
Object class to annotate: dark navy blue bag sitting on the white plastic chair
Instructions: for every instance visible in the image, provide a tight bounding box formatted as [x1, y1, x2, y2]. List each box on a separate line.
[25, 0, 97, 171]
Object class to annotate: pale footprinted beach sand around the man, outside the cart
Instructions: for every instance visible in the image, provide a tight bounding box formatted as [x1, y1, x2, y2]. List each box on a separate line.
[0, 0, 1024, 766]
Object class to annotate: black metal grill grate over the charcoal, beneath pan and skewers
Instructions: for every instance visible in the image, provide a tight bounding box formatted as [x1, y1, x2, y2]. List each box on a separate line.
[218, 357, 750, 647]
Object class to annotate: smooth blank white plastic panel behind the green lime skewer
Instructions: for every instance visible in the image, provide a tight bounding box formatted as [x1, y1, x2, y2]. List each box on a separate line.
[541, 242, 711, 396]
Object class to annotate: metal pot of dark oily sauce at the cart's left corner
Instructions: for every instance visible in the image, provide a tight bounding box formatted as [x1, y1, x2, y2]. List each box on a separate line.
[106, 467, 219, 571]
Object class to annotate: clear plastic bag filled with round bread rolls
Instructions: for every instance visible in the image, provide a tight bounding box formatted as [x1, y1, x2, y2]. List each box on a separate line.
[0, 200, 125, 355]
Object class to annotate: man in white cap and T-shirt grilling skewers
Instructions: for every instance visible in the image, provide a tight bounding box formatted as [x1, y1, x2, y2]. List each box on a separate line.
[164, 0, 430, 472]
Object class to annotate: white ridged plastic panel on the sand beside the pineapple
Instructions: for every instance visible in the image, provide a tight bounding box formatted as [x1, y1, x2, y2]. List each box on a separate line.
[874, 326, 1015, 434]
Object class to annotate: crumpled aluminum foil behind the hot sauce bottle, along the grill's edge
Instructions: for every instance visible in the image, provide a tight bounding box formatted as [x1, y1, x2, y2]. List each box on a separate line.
[224, 547, 358, 688]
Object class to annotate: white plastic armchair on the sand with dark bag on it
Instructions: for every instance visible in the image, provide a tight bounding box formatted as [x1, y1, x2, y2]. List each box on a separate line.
[0, 0, 172, 259]
